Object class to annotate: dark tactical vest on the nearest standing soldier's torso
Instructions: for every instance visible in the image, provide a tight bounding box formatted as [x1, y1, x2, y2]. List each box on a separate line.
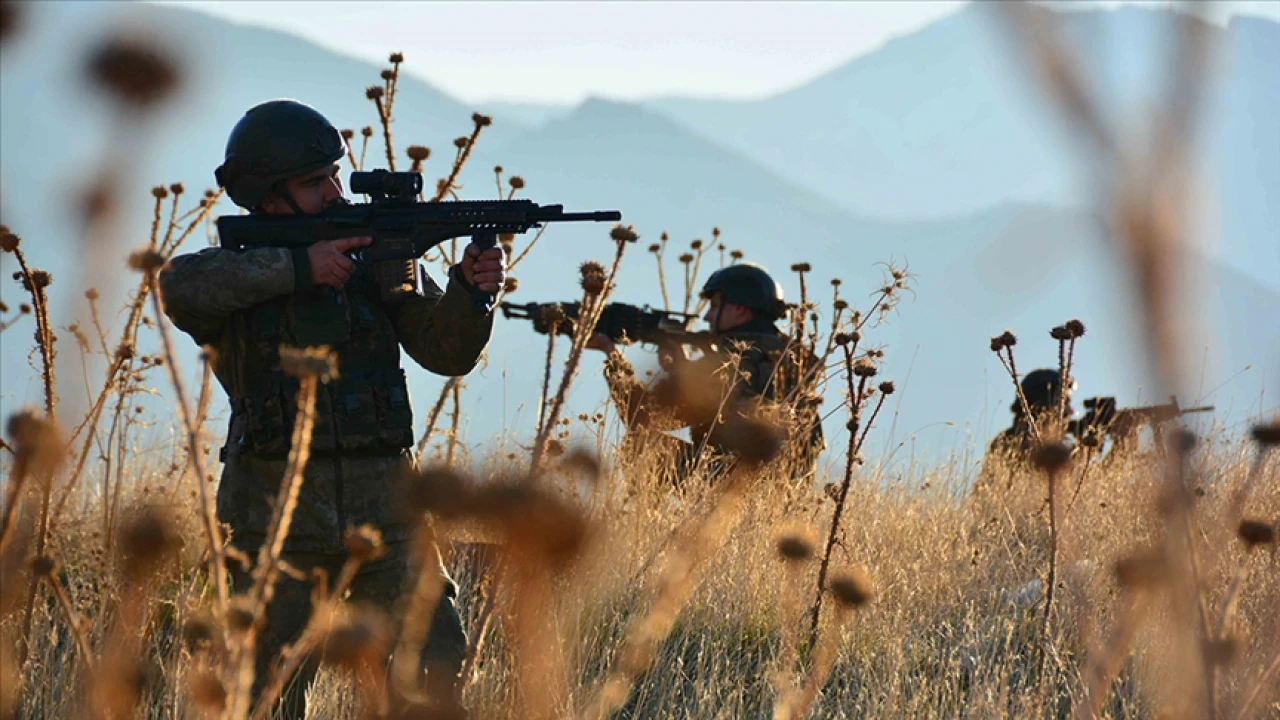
[229, 265, 413, 457]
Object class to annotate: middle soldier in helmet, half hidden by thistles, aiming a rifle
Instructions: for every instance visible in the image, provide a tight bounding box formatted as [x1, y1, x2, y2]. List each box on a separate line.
[586, 264, 823, 484]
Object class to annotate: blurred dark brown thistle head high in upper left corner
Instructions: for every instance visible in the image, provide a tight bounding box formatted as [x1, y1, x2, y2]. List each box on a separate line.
[86, 37, 182, 109]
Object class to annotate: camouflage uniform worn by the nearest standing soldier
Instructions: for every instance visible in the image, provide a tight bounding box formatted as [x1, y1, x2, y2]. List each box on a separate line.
[159, 101, 493, 719]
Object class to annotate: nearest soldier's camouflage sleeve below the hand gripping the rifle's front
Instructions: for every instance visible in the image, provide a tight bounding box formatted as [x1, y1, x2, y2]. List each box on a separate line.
[389, 266, 493, 377]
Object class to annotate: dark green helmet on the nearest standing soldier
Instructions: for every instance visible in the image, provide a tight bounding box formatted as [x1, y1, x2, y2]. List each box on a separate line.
[214, 100, 347, 210]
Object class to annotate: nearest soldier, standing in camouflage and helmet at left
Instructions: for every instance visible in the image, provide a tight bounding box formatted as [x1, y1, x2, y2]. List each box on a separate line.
[160, 100, 506, 719]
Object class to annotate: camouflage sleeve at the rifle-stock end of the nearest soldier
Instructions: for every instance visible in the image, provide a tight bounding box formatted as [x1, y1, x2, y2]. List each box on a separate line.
[159, 247, 302, 345]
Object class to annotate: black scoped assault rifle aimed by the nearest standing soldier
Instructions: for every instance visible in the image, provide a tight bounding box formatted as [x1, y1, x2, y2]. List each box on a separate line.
[218, 170, 622, 313]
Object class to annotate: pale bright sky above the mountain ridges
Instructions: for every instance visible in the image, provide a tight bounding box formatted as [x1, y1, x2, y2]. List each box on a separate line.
[157, 0, 1280, 104]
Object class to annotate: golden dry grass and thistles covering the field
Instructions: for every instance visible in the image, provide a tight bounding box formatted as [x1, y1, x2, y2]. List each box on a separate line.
[0, 7, 1280, 720]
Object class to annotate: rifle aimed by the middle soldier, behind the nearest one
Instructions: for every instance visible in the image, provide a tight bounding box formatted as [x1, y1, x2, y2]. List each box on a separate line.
[502, 302, 713, 348]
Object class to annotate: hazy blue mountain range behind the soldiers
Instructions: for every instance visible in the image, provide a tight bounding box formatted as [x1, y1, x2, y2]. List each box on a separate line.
[0, 4, 1280, 471]
